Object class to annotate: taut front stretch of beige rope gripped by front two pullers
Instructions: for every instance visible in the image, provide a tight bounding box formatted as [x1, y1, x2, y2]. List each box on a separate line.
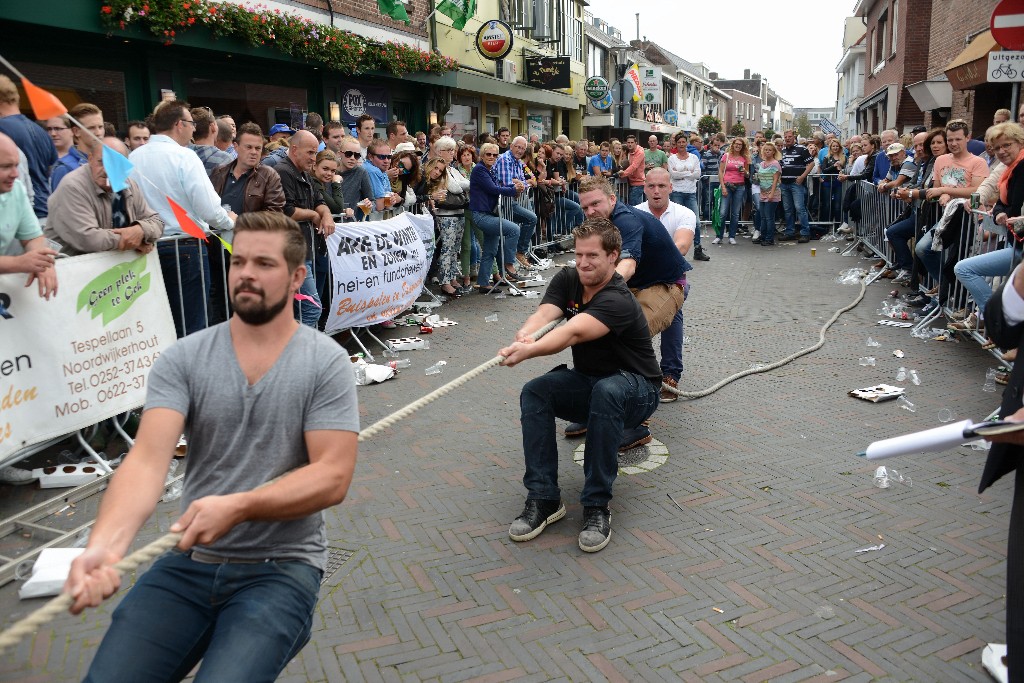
[0, 319, 561, 654]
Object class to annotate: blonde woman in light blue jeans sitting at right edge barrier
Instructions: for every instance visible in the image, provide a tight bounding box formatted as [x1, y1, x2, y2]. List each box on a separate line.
[949, 123, 1024, 330]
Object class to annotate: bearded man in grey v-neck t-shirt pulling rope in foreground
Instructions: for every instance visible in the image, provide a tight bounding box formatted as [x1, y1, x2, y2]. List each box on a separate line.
[66, 212, 359, 681]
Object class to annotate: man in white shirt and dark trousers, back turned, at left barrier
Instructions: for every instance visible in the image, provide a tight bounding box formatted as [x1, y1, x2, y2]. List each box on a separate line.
[128, 100, 234, 338]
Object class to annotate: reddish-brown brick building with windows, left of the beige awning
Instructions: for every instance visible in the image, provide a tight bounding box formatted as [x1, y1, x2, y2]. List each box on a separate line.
[853, 0, 933, 133]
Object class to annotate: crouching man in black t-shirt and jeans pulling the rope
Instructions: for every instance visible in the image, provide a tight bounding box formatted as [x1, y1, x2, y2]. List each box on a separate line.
[499, 218, 662, 553]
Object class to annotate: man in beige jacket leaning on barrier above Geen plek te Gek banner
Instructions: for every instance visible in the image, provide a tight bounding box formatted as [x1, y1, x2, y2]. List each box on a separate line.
[45, 137, 164, 256]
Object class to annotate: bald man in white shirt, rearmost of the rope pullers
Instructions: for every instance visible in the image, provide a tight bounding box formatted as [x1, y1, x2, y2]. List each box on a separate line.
[637, 168, 697, 403]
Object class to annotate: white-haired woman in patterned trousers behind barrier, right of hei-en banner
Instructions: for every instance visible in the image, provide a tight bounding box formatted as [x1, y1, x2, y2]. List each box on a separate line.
[424, 156, 469, 297]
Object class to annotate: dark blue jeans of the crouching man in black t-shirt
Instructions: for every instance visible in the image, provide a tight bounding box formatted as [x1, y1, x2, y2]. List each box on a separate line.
[519, 366, 660, 507]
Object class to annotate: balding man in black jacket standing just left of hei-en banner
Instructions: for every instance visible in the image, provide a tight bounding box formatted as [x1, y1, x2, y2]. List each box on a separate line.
[274, 130, 334, 328]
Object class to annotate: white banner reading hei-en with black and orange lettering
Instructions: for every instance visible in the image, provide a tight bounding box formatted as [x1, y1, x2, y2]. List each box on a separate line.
[327, 212, 434, 334]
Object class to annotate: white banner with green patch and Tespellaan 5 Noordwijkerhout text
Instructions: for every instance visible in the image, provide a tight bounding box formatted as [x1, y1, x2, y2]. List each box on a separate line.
[0, 252, 175, 460]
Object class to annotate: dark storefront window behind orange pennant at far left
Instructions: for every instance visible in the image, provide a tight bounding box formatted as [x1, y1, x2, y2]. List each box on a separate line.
[14, 61, 128, 131]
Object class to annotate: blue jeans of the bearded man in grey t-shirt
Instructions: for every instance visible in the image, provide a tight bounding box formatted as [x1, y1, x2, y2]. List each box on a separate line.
[85, 551, 322, 683]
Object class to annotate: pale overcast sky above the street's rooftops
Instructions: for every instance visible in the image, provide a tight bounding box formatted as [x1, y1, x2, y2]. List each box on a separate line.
[588, 0, 855, 106]
